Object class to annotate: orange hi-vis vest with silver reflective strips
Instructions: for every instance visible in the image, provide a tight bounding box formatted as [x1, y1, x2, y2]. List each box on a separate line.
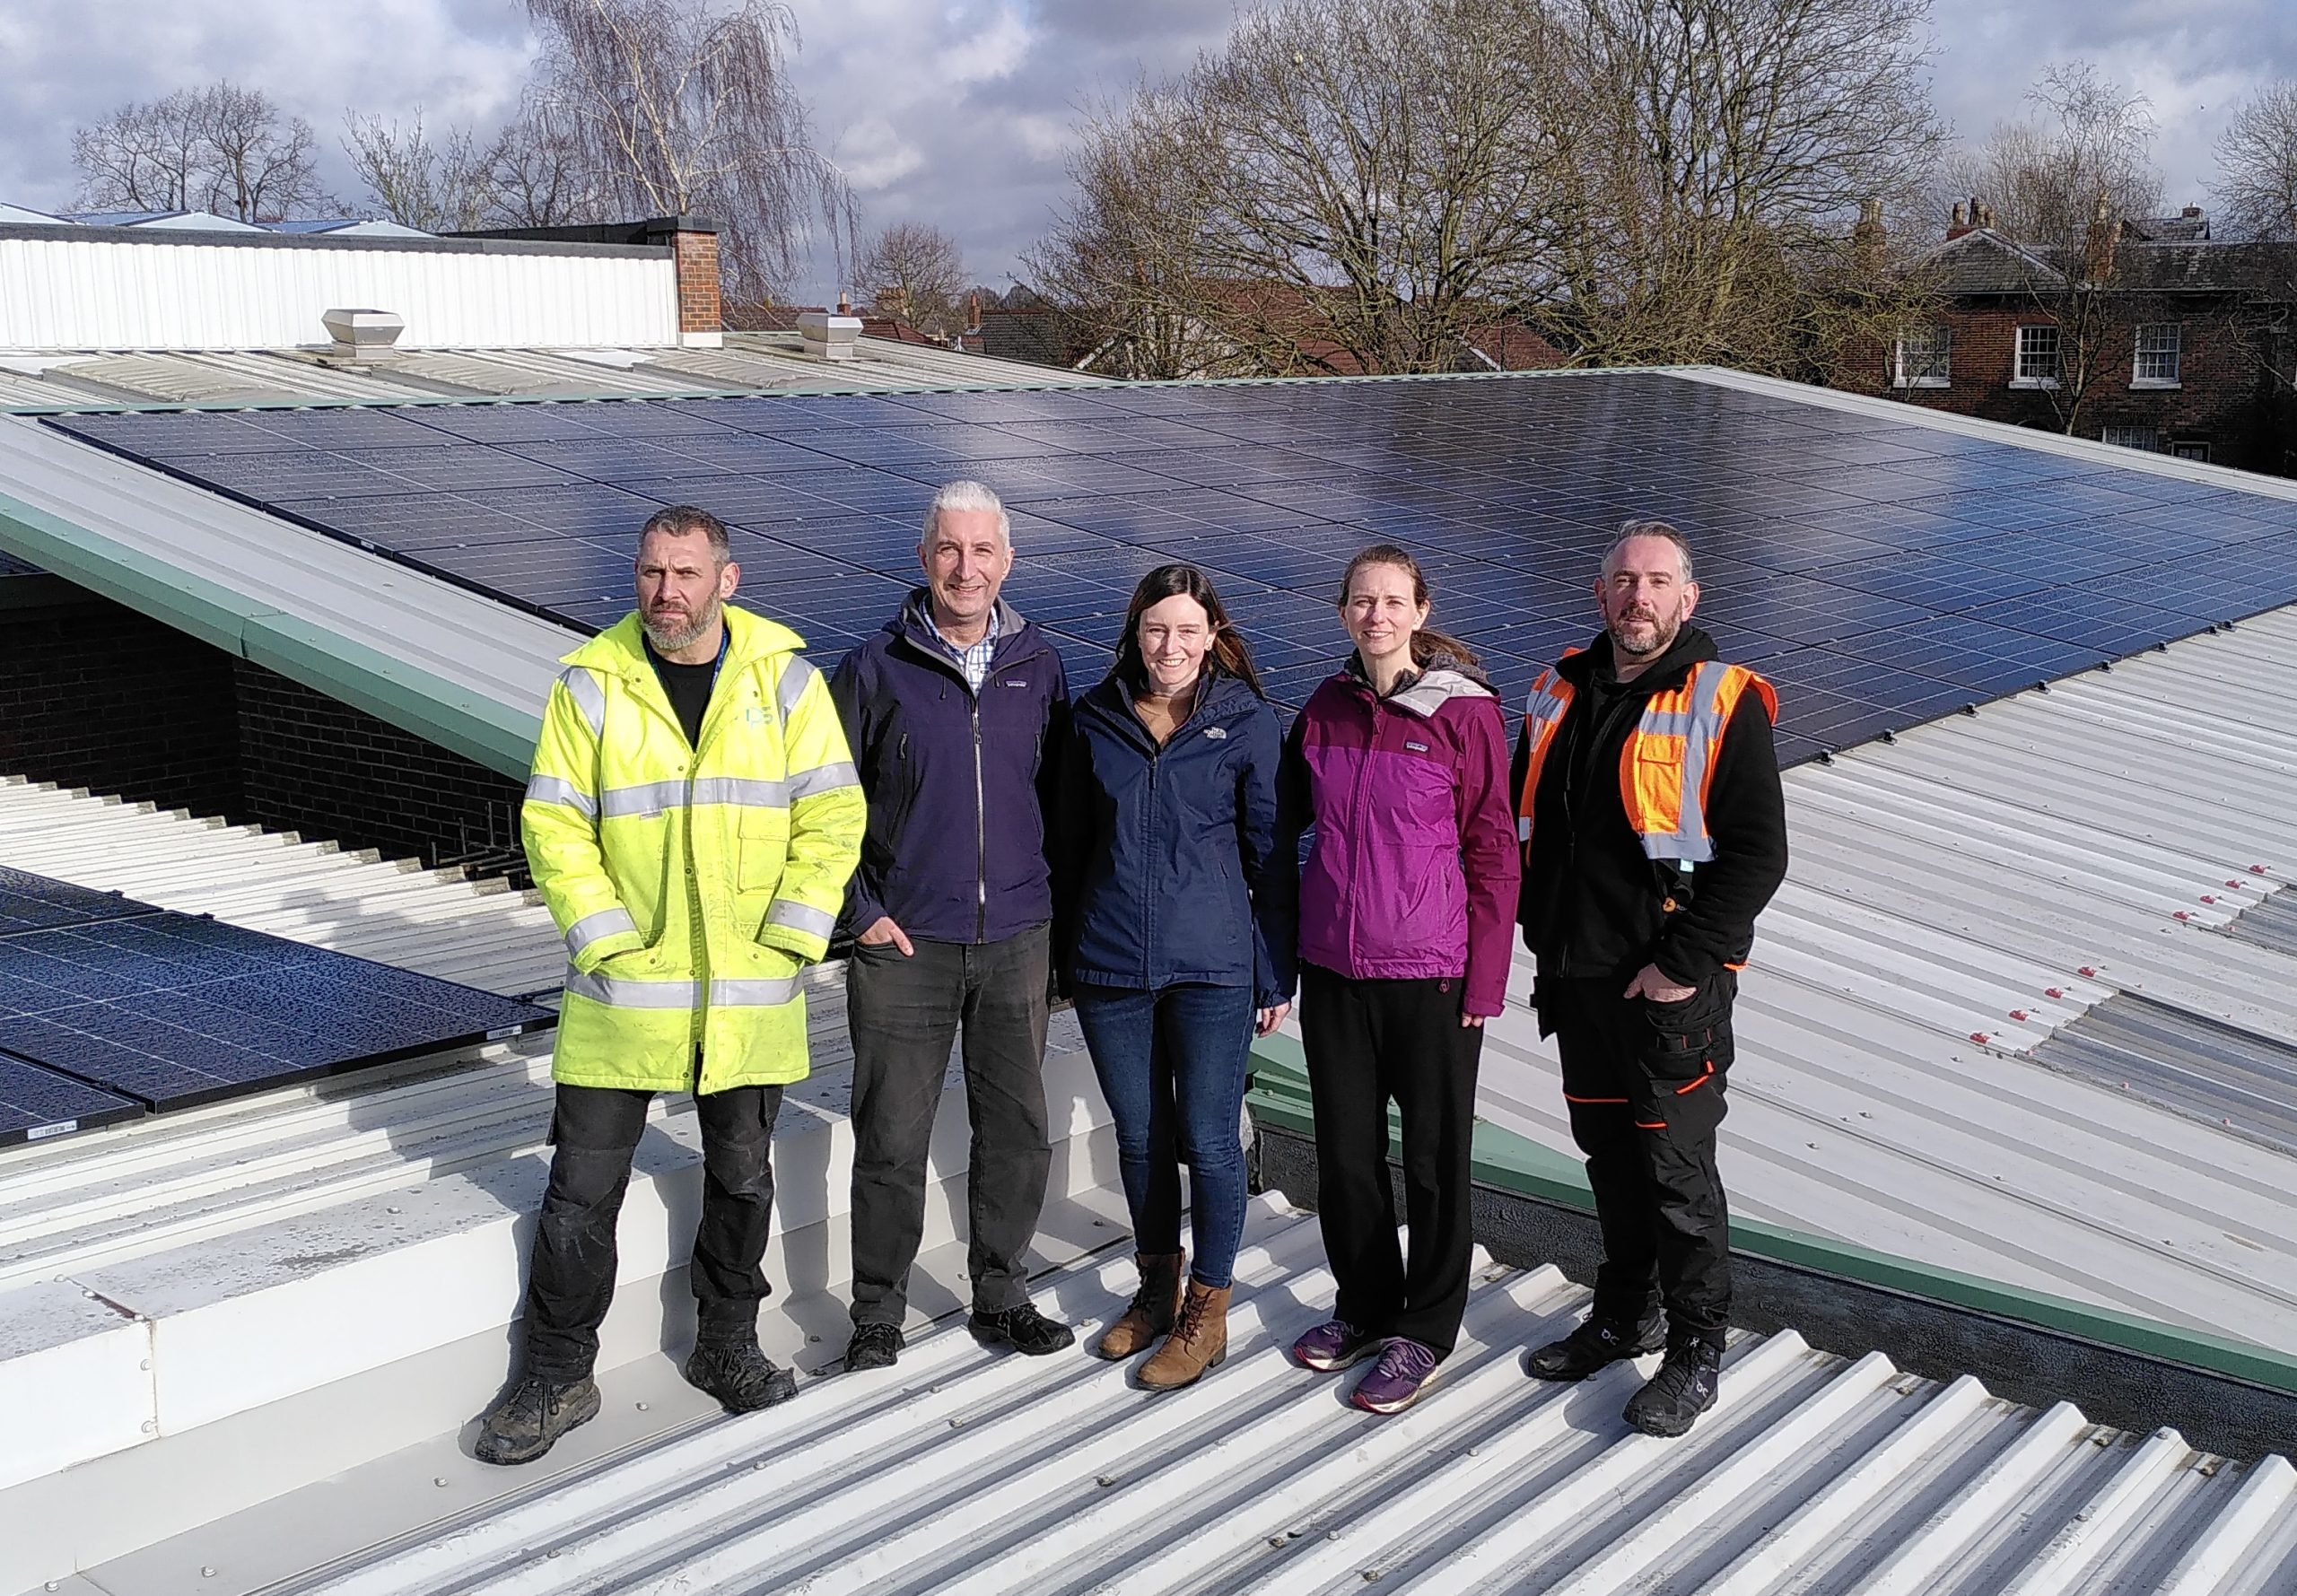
[1516, 648, 1777, 863]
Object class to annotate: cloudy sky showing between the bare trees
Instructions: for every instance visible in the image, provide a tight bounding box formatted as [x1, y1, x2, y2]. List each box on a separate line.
[0, 0, 2297, 299]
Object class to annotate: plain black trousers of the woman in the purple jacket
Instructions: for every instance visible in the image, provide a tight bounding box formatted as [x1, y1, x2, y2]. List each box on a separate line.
[1300, 964, 1484, 1357]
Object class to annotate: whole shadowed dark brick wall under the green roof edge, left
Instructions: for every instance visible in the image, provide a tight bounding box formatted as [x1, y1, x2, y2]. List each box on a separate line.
[0, 576, 526, 886]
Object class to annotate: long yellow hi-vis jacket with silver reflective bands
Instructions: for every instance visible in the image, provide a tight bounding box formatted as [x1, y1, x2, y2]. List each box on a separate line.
[520, 606, 866, 1091]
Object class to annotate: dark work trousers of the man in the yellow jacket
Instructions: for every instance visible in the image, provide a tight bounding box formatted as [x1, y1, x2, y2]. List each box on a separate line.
[526, 1086, 781, 1385]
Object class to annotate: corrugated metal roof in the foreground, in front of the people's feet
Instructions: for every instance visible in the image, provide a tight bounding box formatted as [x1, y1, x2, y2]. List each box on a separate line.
[237, 1201, 2297, 1596]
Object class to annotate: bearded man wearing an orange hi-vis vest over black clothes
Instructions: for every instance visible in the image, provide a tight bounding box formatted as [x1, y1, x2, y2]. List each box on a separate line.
[1514, 521, 1787, 1435]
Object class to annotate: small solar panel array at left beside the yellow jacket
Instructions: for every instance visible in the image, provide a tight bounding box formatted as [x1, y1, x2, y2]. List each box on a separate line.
[0, 868, 551, 1144]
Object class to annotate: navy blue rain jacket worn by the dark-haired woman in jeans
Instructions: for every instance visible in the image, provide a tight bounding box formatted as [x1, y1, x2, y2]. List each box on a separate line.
[1057, 676, 1291, 1008]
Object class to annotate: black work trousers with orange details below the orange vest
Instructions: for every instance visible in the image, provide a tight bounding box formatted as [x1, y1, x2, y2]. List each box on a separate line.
[1539, 972, 1739, 1346]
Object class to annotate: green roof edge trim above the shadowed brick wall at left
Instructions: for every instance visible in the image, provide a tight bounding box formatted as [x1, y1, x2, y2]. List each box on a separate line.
[0, 493, 542, 781]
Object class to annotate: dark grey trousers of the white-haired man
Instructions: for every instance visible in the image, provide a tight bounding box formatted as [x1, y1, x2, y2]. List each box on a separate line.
[845, 926, 1052, 1325]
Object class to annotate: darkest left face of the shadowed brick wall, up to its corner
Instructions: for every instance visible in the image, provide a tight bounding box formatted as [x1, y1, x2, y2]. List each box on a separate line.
[0, 576, 239, 815]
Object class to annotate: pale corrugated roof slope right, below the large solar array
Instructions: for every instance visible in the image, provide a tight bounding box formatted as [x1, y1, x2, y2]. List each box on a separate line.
[1481, 611, 2297, 1353]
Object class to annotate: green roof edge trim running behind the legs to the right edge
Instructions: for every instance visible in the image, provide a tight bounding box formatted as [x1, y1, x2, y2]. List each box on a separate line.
[1245, 1035, 2297, 1391]
